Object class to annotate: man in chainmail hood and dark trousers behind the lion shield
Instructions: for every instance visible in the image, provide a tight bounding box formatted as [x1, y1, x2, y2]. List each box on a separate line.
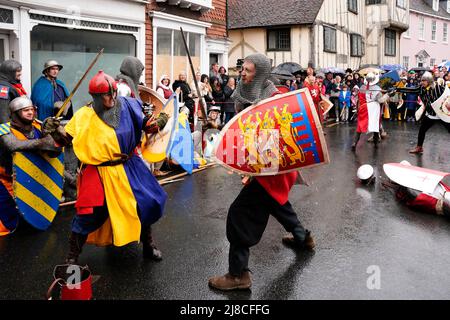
[209, 54, 314, 290]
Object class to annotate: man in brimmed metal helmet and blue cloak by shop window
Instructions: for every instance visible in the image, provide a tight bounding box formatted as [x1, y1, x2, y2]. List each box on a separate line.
[31, 60, 73, 120]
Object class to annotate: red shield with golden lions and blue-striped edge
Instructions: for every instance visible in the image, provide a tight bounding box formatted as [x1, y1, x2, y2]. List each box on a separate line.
[214, 89, 329, 176]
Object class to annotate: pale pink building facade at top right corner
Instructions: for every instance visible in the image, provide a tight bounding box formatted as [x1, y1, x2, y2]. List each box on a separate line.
[400, 0, 450, 69]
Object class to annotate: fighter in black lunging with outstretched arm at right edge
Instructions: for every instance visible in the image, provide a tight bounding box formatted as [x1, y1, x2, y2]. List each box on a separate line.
[396, 72, 450, 154]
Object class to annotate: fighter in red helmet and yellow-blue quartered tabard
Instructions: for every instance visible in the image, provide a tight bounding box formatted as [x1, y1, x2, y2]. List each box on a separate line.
[43, 71, 167, 264]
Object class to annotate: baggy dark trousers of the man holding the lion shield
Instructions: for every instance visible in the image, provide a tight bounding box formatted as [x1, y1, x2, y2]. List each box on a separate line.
[227, 180, 305, 276]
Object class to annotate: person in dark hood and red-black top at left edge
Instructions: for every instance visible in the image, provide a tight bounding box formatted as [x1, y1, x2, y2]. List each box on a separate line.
[0, 60, 27, 123]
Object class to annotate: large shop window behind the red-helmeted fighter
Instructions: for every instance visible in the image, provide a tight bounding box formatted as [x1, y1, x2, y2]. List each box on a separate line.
[31, 25, 136, 110]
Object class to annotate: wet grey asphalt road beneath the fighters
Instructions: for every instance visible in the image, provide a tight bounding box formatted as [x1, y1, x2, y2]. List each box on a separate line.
[0, 123, 450, 300]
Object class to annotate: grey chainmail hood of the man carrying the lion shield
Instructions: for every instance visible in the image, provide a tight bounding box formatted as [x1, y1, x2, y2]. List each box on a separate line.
[231, 53, 278, 111]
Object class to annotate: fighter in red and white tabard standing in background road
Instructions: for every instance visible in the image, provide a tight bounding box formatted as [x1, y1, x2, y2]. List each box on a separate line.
[352, 73, 389, 150]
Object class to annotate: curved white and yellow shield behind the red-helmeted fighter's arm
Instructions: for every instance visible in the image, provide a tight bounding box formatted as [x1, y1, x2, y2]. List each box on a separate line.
[142, 94, 179, 163]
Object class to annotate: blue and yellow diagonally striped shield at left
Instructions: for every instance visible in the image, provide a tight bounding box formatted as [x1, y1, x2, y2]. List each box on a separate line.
[13, 152, 64, 230]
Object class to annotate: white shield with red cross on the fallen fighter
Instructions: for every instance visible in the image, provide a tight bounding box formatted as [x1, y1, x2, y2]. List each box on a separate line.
[383, 161, 450, 194]
